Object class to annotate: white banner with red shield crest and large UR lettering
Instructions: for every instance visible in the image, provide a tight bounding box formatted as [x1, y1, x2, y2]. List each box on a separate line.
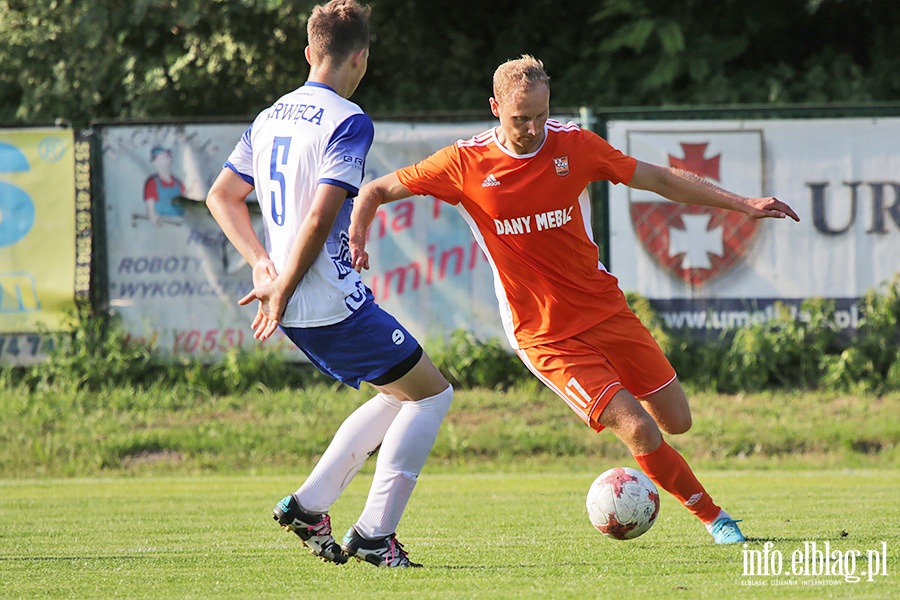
[608, 118, 900, 334]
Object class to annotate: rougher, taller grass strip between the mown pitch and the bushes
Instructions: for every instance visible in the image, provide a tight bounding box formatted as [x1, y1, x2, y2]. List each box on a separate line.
[0, 380, 900, 479]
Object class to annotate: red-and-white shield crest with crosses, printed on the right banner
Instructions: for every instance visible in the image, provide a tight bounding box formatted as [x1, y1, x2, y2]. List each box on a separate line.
[630, 132, 762, 287]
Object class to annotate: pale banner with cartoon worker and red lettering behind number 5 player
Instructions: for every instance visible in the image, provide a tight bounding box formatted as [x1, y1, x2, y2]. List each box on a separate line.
[101, 122, 540, 360]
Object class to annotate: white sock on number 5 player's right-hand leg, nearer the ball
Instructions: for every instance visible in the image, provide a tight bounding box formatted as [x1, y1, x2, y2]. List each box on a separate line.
[356, 386, 453, 539]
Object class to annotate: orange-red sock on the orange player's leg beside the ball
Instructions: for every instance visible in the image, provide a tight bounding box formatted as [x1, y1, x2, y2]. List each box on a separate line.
[634, 440, 720, 523]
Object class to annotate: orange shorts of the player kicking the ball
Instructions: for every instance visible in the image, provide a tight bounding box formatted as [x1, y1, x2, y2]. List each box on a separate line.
[516, 306, 675, 431]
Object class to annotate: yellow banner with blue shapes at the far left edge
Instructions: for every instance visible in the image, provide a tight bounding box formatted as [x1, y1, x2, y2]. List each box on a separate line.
[0, 127, 76, 364]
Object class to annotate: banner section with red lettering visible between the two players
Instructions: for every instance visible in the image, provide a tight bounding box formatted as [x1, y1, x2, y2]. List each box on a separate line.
[363, 122, 506, 342]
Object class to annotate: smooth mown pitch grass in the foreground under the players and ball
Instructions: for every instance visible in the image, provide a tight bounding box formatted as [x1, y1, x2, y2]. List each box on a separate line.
[0, 472, 900, 600]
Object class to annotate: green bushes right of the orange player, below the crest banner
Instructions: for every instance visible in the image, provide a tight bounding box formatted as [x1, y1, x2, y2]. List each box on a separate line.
[668, 278, 900, 394]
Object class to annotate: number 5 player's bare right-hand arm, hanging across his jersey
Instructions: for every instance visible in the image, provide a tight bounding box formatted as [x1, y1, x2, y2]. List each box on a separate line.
[238, 184, 347, 341]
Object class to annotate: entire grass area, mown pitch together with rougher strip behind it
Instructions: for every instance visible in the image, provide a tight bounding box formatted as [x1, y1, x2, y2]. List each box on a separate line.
[0, 384, 900, 600]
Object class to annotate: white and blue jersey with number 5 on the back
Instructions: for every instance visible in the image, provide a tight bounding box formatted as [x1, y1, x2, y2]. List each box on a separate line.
[225, 82, 375, 327]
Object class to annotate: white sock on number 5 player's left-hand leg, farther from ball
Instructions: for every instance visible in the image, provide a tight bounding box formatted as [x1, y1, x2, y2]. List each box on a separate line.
[294, 394, 401, 513]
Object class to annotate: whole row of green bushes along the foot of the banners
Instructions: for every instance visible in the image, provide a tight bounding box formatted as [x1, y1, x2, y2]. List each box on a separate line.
[0, 277, 900, 397]
